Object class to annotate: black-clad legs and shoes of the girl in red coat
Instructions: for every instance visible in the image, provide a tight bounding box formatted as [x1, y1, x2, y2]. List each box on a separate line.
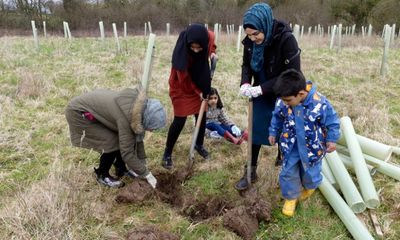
[162, 114, 209, 169]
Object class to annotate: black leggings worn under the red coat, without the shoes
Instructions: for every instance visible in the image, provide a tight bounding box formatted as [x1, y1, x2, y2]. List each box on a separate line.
[165, 113, 206, 155]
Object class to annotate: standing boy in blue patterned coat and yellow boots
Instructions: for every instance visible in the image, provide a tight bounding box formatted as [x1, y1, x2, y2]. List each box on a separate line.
[268, 69, 340, 216]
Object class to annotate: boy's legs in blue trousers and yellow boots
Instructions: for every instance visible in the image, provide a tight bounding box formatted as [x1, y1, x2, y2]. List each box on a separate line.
[279, 149, 322, 216]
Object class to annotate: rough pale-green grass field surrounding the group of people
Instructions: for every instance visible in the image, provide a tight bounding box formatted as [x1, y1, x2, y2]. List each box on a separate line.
[0, 32, 400, 240]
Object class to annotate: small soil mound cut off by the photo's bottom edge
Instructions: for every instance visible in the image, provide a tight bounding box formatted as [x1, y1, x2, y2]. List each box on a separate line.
[126, 225, 179, 240]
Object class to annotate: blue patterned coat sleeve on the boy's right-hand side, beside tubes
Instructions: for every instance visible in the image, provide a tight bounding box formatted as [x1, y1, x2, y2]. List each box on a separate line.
[321, 100, 340, 143]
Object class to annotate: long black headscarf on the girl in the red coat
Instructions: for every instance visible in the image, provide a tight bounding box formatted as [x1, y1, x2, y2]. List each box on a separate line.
[172, 24, 211, 98]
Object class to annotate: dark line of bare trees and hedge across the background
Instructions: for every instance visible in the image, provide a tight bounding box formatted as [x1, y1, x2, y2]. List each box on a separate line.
[0, 0, 400, 35]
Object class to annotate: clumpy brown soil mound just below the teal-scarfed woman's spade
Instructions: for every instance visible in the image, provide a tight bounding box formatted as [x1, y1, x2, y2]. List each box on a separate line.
[223, 189, 271, 240]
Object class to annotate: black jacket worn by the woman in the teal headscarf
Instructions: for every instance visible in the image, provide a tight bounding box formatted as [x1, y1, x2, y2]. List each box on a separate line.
[240, 20, 300, 101]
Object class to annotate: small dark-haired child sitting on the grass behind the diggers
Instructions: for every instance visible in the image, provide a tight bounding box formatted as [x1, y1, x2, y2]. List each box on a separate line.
[206, 88, 248, 145]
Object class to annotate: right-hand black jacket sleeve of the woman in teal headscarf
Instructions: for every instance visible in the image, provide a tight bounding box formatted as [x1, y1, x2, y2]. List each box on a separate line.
[261, 33, 301, 94]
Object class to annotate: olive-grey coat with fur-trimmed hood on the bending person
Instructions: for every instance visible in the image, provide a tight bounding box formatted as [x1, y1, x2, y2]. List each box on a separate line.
[66, 88, 148, 176]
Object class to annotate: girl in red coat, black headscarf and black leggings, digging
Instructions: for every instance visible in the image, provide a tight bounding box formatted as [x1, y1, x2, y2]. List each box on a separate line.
[162, 24, 216, 169]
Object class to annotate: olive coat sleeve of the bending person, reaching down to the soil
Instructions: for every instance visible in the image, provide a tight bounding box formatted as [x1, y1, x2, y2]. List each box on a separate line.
[117, 117, 149, 177]
